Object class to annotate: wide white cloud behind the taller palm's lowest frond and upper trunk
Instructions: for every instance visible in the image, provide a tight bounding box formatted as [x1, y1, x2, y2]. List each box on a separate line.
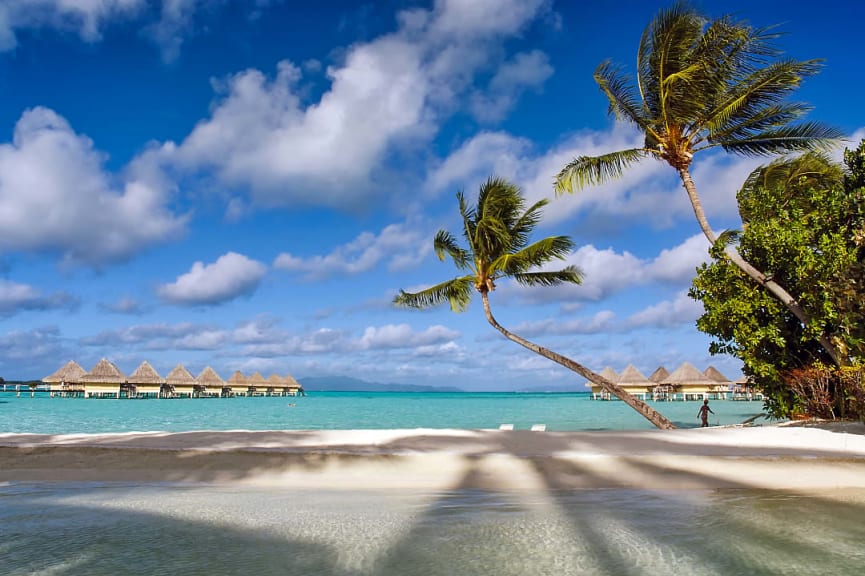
[425, 123, 760, 230]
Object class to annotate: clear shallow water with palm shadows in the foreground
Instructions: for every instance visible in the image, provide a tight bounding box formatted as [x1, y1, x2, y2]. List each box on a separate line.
[0, 484, 865, 576]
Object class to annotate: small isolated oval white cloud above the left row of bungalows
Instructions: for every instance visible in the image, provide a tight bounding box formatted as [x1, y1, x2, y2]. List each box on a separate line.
[157, 252, 267, 305]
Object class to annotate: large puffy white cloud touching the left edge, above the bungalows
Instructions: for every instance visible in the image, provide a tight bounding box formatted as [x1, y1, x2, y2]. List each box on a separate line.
[0, 108, 187, 266]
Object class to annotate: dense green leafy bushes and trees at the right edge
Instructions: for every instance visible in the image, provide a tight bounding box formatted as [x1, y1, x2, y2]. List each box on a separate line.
[690, 141, 865, 419]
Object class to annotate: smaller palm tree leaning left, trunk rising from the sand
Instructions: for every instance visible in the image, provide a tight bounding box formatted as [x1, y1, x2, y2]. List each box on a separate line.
[394, 177, 675, 429]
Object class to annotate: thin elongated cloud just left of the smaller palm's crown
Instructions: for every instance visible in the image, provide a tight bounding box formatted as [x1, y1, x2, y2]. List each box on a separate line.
[273, 224, 431, 280]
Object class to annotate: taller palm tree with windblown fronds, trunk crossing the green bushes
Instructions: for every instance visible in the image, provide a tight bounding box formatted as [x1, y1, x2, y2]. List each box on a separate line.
[555, 2, 845, 364]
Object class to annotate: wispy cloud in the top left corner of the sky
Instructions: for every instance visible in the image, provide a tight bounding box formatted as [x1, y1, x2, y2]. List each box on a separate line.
[0, 0, 142, 51]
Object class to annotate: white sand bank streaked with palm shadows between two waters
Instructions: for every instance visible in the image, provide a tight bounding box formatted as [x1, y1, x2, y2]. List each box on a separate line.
[0, 424, 865, 492]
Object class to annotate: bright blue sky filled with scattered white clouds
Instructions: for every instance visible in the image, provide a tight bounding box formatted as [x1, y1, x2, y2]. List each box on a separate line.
[0, 0, 865, 389]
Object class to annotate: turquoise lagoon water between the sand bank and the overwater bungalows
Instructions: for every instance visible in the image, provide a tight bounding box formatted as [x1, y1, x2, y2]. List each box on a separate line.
[0, 392, 762, 434]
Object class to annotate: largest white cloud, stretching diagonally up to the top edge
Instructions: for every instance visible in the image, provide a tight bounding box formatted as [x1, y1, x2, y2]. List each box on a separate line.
[164, 0, 550, 208]
